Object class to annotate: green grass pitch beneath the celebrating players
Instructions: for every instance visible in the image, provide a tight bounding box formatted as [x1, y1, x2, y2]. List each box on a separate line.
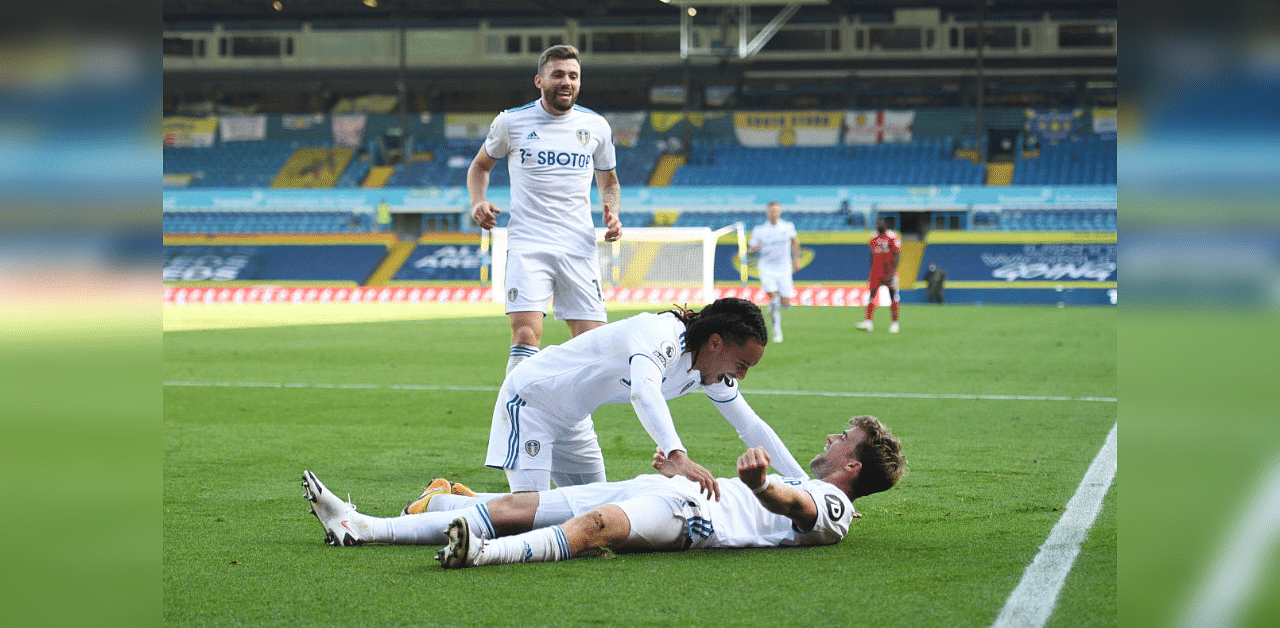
[163, 304, 1119, 627]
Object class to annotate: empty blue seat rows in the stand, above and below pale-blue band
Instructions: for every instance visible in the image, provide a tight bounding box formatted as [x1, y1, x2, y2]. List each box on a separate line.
[164, 120, 1116, 234]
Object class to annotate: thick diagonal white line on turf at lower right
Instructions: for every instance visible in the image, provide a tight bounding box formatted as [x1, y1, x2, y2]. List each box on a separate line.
[991, 423, 1119, 628]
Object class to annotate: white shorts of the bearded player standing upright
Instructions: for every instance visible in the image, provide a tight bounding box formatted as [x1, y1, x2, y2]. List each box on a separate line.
[506, 251, 608, 322]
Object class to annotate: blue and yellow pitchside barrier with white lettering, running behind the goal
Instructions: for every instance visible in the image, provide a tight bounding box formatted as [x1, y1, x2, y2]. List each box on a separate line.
[163, 230, 1119, 307]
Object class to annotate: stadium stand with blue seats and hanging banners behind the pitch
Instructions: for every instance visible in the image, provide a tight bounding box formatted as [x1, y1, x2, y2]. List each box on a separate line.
[163, 0, 1117, 308]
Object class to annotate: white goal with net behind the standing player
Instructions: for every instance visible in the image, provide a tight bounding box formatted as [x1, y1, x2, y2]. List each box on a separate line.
[481, 223, 746, 303]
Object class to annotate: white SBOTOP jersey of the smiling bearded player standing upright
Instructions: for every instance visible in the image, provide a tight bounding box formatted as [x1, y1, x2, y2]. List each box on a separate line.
[484, 100, 617, 256]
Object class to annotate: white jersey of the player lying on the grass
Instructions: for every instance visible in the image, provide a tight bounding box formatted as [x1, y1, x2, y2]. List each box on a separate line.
[680, 473, 855, 547]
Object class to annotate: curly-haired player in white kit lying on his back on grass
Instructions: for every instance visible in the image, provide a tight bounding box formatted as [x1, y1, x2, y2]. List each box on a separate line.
[302, 416, 906, 569]
